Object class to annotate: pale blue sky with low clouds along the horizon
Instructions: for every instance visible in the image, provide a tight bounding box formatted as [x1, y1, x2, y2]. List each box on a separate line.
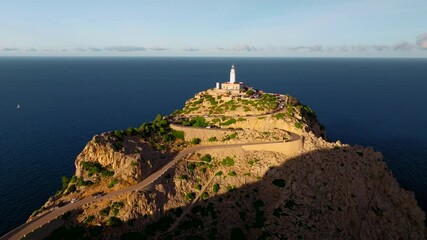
[0, 0, 427, 58]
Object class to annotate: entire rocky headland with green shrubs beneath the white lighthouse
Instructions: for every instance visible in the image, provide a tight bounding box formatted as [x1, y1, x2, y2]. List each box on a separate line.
[22, 86, 426, 239]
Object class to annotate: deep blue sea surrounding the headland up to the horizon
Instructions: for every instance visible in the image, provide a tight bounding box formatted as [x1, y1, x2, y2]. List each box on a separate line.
[0, 57, 427, 235]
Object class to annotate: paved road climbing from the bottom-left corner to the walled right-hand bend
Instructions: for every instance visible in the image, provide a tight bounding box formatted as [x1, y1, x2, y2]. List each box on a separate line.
[0, 138, 301, 240]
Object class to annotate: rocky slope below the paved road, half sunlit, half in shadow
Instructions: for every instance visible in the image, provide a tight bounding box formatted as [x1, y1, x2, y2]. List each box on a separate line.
[72, 134, 425, 239]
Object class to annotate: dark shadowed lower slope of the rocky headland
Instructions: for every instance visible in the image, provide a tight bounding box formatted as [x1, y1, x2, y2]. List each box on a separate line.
[43, 147, 425, 239]
